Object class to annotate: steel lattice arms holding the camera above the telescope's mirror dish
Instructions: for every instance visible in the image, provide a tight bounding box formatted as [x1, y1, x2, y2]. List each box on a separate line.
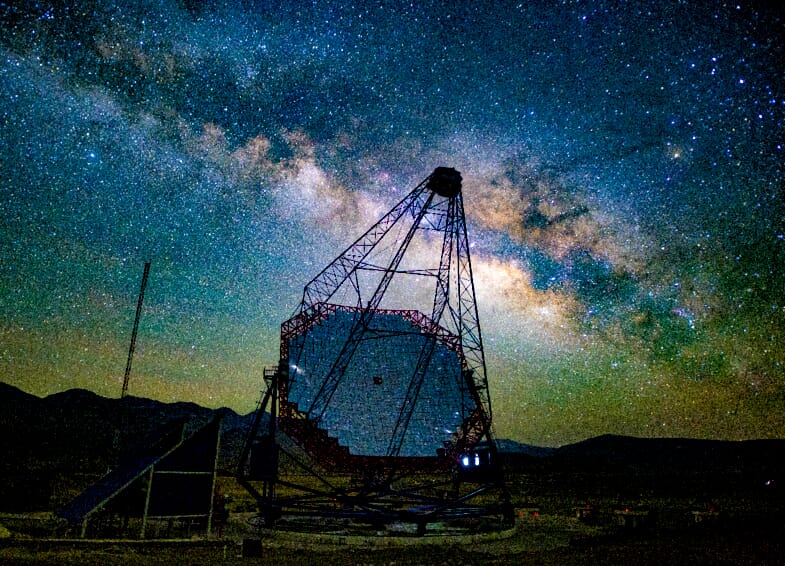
[278, 167, 491, 466]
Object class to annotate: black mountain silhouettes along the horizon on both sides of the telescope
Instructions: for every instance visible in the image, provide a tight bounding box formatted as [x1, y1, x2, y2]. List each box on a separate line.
[0, 382, 785, 511]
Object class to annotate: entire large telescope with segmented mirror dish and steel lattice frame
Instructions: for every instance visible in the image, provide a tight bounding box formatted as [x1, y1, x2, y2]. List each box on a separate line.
[237, 167, 514, 534]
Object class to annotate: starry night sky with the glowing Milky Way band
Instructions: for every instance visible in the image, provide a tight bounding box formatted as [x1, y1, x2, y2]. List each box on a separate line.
[0, 0, 785, 445]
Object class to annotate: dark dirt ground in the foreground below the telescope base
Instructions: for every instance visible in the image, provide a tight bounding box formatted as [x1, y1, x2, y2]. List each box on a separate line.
[0, 477, 785, 566]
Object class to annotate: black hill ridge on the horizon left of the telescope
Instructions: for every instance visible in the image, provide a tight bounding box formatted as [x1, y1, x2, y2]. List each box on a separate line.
[0, 382, 251, 473]
